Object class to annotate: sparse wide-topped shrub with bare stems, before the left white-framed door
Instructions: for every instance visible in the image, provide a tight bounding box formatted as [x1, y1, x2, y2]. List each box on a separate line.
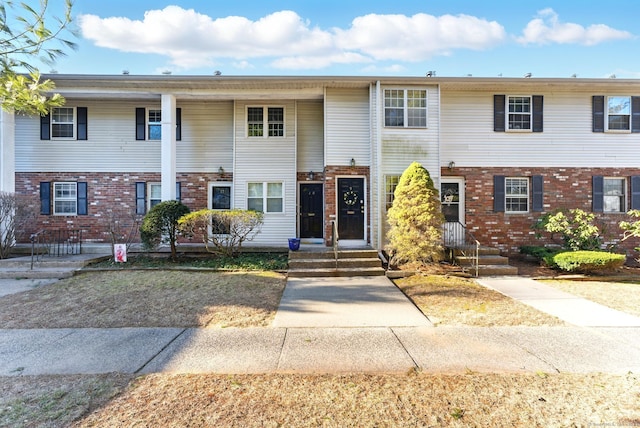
[178, 209, 264, 257]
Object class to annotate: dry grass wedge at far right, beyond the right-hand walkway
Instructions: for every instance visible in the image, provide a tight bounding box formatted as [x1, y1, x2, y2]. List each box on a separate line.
[544, 278, 640, 317]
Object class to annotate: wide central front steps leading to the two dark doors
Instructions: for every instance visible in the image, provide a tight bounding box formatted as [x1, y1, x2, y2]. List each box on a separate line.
[289, 249, 385, 278]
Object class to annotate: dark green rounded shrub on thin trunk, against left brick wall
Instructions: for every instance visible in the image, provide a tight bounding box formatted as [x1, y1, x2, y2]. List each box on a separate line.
[140, 201, 189, 260]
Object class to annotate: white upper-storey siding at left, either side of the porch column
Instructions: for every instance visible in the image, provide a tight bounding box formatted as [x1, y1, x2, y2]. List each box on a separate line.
[15, 99, 233, 173]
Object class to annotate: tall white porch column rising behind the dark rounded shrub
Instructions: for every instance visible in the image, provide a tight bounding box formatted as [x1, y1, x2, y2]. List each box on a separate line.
[160, 94, 176, 201]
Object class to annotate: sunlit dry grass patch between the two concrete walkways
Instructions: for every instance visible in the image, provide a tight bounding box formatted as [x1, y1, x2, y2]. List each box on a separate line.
[395, 275, 564, 327]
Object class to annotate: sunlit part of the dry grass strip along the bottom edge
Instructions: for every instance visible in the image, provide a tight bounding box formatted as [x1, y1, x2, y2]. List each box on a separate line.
[70, 373, 640, 427]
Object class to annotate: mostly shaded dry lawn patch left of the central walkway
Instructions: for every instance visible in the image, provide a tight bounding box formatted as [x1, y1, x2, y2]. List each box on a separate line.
[0, 270, 285, 328]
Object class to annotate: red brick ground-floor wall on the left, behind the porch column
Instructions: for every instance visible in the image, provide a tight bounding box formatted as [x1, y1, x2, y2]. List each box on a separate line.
[16, 172, 233, 242]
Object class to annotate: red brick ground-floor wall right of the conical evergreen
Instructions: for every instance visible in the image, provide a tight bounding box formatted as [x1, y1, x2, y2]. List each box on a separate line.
[441, 167, 640, 256]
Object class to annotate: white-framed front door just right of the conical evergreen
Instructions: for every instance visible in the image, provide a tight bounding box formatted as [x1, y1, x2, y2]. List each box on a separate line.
[440, 178, 465, 245]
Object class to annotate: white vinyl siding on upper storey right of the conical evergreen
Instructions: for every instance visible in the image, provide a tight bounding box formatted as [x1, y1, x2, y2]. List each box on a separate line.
[441, 87, 640, 168]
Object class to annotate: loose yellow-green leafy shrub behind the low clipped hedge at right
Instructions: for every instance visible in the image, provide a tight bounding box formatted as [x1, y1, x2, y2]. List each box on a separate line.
[533, 209, 602, 251]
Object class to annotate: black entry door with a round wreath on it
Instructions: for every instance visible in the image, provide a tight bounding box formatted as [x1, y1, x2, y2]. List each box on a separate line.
[338, 178, 364, 239]
